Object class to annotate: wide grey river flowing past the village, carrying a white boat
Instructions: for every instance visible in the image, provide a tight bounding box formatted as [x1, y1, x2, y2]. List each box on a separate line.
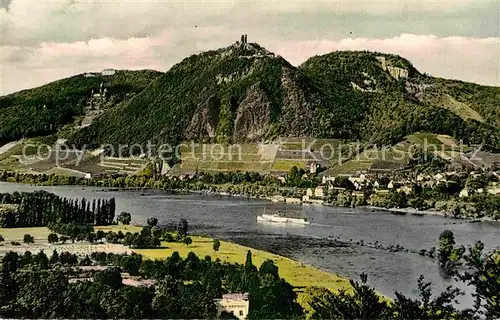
[0, 183, 500, 305]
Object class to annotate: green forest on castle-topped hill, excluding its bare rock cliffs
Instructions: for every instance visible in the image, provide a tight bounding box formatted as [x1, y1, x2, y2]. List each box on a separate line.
[71, 47, 304, 149]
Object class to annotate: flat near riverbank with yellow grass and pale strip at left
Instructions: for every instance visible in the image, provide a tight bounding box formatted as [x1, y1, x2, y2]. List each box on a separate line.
[0, 226, 350, 291]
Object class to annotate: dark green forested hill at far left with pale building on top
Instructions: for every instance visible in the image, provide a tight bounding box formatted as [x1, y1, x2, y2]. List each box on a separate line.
[0, 70, 161, 144]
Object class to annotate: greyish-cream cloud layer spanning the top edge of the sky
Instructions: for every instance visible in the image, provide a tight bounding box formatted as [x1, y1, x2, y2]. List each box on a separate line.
[0, 0, 498, 46]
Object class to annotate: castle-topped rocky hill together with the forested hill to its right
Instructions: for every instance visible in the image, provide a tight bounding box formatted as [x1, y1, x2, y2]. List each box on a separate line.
[64, 42, 500, 152]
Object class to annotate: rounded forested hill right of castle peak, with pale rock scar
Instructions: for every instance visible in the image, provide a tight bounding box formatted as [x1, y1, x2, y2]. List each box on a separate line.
[299, 51, 500, 151]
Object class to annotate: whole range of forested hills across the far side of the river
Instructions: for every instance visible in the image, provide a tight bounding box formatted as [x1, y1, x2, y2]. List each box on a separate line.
[0, 42, 500, 152]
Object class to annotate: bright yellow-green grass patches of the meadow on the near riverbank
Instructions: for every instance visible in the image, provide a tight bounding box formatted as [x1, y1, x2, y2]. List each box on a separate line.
[0, 226, 350, 290]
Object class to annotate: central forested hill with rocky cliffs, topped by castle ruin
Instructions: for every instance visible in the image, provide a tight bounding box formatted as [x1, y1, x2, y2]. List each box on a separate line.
[69, 42, 323, 149]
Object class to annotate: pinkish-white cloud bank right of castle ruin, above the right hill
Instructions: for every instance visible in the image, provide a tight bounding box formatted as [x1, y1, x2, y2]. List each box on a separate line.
[269, 34, 500, 86]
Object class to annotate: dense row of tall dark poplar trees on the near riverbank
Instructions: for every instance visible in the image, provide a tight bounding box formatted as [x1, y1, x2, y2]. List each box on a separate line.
[0, 191, 116, 228]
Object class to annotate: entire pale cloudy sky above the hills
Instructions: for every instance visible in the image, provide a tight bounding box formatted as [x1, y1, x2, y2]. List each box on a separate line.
[0, 0, 500, 95]
